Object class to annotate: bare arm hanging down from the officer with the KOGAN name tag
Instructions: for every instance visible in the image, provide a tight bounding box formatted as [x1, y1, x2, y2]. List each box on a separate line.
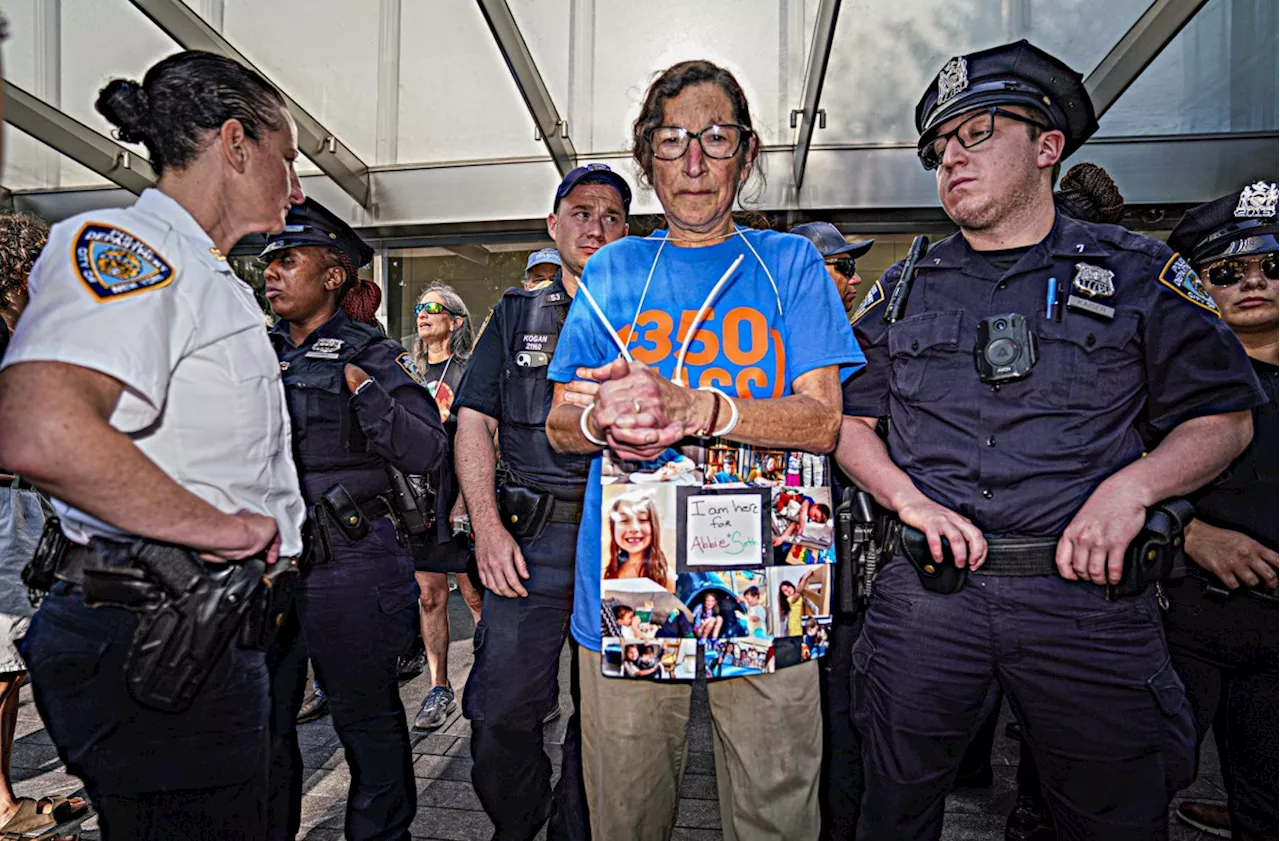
[453, 406, 529, 598]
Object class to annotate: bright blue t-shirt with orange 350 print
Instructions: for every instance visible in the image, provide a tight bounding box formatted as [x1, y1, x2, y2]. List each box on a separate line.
[547, 229, 864, 652]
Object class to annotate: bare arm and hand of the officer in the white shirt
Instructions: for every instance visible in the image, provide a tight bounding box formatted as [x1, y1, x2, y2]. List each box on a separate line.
[0, 362, 276, 559]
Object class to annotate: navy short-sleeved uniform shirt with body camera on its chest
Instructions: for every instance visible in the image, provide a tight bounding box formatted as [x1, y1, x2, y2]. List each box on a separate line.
[845, 214, 1263, 536]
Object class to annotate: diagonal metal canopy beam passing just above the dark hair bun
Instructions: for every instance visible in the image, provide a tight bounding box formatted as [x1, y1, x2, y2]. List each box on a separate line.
[131, 0, 371, 209]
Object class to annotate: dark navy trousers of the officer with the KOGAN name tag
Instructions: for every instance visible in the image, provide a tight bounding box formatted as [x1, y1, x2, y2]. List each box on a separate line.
[462, 522, 590, 841]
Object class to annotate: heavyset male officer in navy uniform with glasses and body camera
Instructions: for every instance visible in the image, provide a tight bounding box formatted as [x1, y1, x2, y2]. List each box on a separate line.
[838, 41, 1262, 841]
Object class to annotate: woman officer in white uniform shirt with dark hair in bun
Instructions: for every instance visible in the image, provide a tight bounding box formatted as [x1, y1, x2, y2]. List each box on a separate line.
[0, 51, 303, 841]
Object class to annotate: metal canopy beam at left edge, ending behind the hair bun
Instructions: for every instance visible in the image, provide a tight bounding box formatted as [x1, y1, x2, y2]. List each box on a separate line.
[4, 79, 156, 193]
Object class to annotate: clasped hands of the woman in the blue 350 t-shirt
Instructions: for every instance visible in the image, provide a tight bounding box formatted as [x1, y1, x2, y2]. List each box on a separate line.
[564, 357, 718, 461]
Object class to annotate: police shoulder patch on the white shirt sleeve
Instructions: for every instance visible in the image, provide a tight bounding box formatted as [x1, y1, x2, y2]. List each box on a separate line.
[72, 221, 173, 301]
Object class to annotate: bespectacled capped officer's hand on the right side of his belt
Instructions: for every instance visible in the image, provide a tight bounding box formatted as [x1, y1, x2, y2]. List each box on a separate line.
[1055, 476, 1147, 585]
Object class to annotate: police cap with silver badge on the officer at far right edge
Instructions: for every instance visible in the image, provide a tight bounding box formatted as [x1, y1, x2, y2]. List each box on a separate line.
[1169, 180, 1280, 265]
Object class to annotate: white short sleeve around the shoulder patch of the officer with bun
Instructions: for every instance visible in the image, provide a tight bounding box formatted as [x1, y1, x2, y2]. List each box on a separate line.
[4, 225, 195, 434]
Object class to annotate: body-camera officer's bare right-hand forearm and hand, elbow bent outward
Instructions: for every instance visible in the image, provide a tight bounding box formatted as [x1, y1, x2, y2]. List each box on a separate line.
[1057, 411, 1253, 584]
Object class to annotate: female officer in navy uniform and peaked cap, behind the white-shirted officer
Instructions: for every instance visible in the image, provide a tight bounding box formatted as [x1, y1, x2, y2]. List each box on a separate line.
[262, 200, 448, 841]
